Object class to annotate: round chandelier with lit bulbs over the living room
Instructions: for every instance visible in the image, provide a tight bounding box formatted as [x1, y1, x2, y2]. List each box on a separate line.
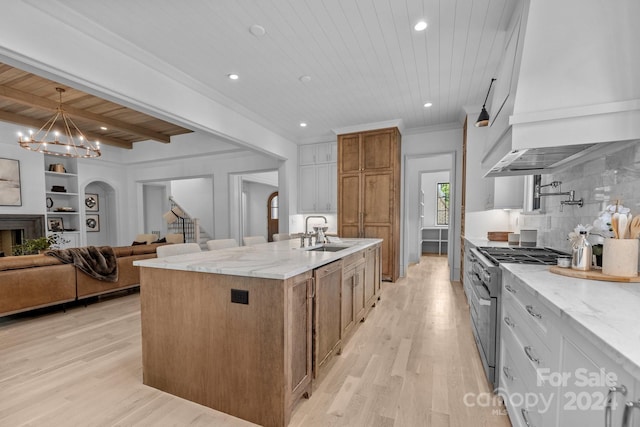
[18, 87, 101, 158]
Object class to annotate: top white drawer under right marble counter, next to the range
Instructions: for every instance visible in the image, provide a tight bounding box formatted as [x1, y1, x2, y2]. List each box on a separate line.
[501, 275, 560, 348]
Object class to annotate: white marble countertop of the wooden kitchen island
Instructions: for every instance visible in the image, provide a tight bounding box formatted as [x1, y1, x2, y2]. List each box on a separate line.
[133, 238, 382, 279]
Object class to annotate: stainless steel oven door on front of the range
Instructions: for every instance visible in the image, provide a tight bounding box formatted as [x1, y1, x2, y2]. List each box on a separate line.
[469, 274, 497, 382]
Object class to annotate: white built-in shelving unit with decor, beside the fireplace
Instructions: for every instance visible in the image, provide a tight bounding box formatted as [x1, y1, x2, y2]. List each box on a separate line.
[44, 155, 81, 248]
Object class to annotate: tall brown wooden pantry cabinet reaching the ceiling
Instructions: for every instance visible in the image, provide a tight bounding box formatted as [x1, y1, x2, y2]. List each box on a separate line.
[338, 128, 401, 282]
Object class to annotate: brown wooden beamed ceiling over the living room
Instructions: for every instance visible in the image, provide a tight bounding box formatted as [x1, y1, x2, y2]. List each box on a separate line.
[0, 63, 191, 149]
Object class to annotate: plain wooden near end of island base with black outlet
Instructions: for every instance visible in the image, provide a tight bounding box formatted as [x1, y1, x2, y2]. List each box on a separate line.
[140, 267, 313, 427]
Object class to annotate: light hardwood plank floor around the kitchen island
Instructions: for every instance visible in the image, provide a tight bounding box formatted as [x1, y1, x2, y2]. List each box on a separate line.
[0, 256, 510, 427]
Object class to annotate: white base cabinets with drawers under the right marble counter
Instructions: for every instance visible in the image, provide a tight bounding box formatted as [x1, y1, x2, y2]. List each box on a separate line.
[499, 270, 640, 427]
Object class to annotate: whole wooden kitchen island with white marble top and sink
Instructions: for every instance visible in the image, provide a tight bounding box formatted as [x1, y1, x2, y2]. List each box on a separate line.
[136, 239, 382, 426]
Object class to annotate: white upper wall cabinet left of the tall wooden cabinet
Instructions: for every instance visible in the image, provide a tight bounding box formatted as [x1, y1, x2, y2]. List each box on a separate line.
[298, 143, 338, 213]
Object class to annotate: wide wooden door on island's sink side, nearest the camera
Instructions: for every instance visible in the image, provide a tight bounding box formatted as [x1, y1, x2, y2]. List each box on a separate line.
[313, 261, 342, 378]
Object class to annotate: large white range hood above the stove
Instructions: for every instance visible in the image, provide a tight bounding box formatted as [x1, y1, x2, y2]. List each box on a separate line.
[482, 0, 640, 176]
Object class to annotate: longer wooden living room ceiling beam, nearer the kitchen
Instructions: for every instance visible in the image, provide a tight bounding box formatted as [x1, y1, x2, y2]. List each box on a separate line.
[0, 85, 171, 144]
